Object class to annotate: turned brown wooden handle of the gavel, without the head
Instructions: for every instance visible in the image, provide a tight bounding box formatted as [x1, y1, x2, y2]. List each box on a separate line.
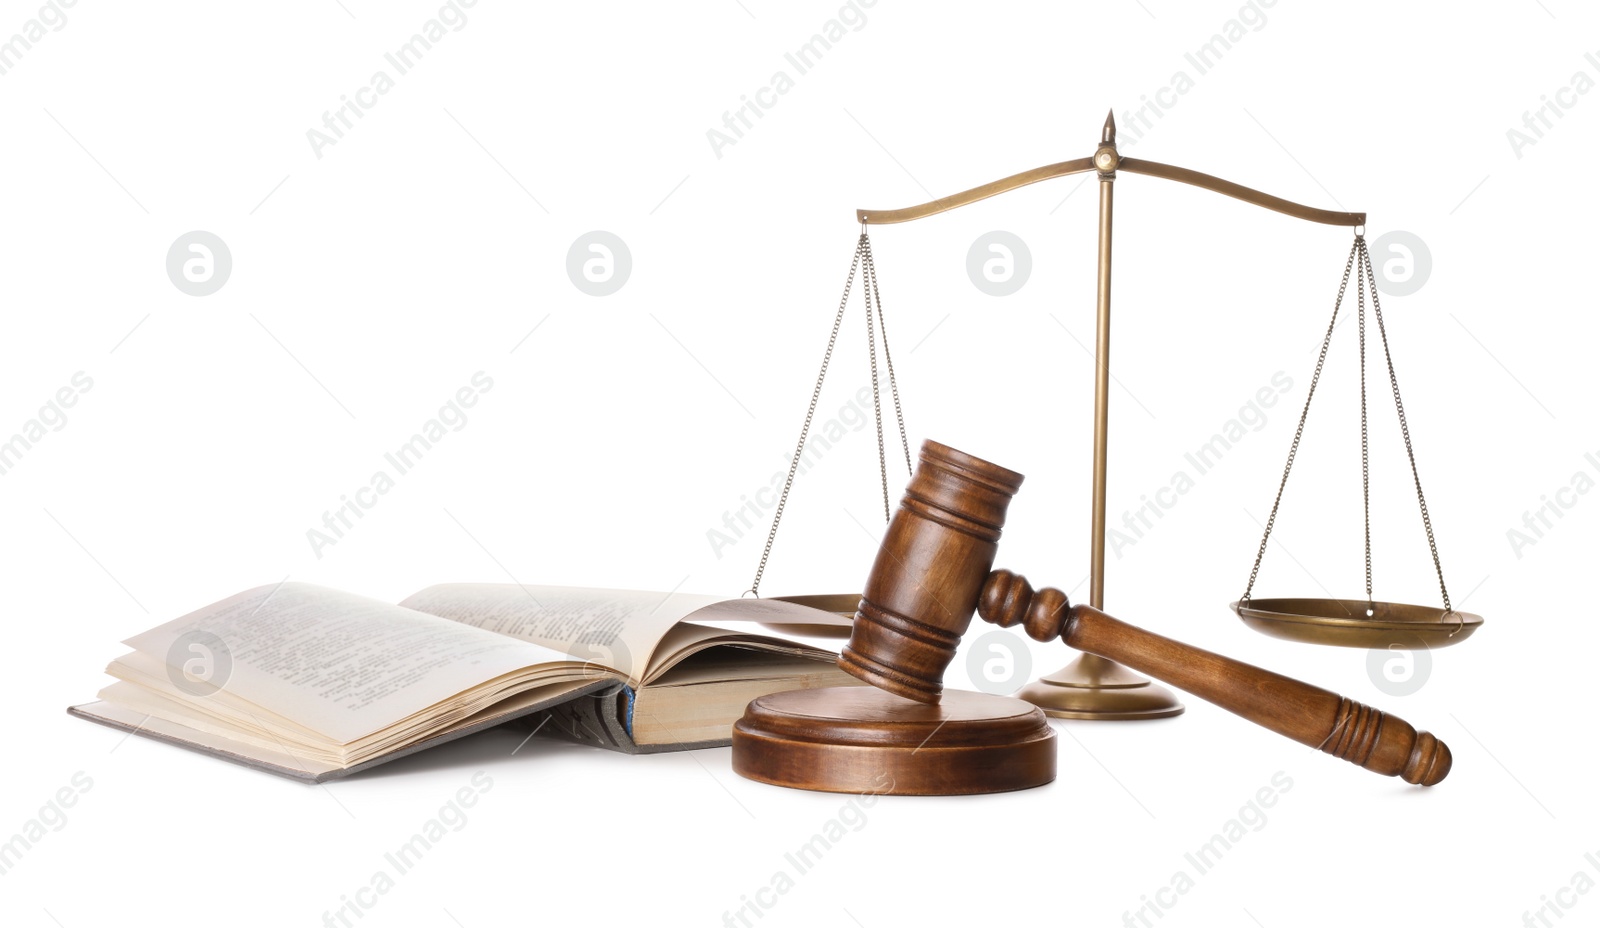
[979, 571, 1451, 786]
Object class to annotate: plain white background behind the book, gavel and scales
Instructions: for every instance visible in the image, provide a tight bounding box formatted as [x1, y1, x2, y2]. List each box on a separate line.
[0, 0, 1600, 928]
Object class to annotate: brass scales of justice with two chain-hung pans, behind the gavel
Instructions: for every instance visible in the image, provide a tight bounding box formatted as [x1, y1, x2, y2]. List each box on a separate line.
[747, 114, 1483, 720]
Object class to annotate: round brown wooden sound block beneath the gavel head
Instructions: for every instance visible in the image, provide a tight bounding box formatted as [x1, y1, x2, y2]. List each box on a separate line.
[733, 686, 1056, 795]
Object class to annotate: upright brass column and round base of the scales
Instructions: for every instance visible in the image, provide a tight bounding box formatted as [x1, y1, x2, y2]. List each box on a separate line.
[1018, 114, 1184, 722]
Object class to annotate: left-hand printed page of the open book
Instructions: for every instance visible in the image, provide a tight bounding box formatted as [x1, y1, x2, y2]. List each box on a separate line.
[123, 582, 568, 744]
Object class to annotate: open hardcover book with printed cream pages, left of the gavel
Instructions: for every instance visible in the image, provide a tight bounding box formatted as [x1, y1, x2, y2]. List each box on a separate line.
[69, 582, 854, 782]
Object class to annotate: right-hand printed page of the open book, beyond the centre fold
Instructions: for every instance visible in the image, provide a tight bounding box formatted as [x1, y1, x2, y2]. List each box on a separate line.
[400, 584, 720, 685]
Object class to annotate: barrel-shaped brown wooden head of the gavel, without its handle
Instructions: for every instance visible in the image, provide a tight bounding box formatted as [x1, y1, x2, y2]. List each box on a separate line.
[838, 442, 1022, 702]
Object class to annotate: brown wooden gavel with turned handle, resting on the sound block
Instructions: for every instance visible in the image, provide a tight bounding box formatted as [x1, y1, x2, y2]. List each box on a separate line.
[838, 442, 1451, 786]
